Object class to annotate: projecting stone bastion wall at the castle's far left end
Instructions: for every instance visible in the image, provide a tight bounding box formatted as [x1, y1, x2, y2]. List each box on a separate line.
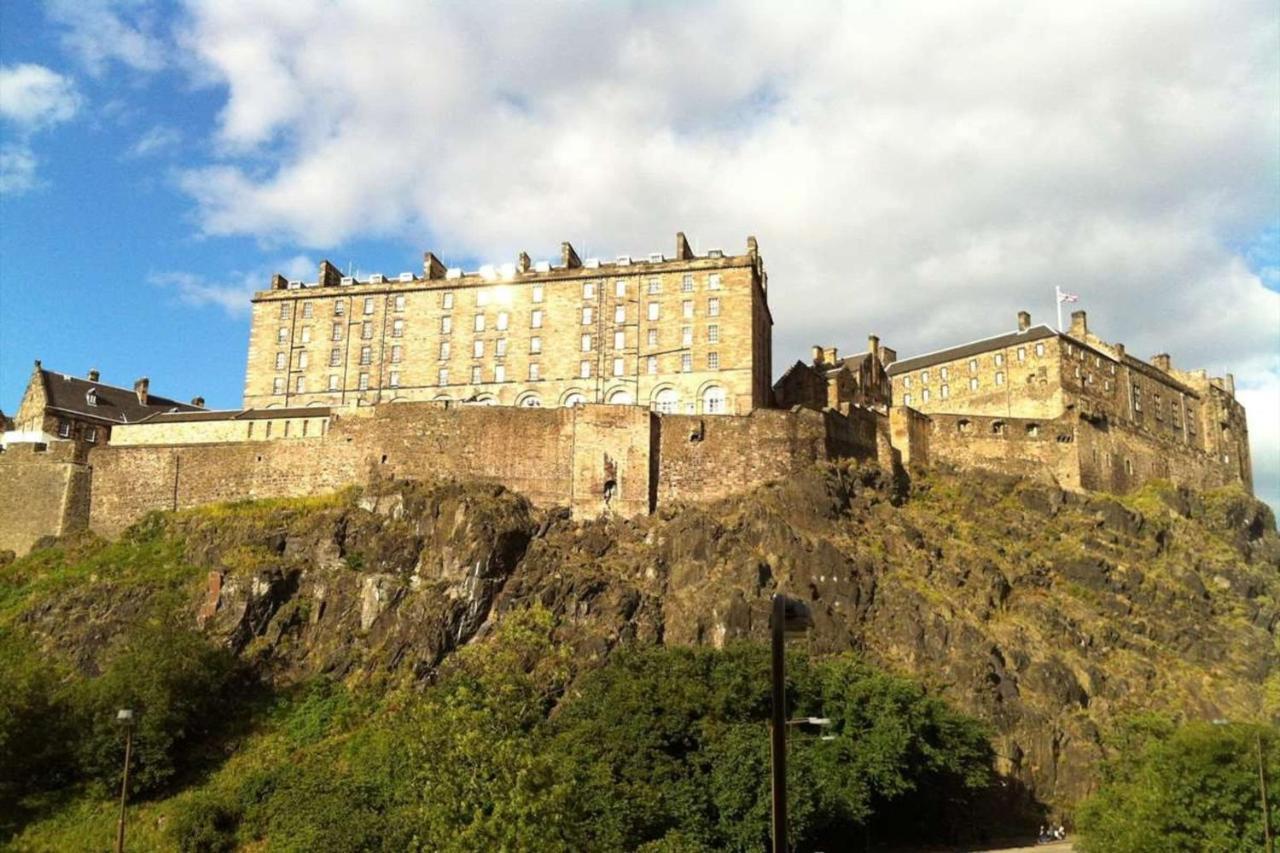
[0, 442, 90, 555]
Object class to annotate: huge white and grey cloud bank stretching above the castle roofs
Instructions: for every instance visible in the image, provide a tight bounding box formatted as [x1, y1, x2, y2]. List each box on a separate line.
[172, 0, 1280, 502]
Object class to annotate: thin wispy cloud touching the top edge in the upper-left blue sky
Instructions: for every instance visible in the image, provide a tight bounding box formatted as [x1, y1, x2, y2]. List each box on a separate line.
[45, 0, 169, 76]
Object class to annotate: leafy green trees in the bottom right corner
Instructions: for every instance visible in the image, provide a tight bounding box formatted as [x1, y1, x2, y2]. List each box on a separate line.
[1079, 716, 1280, 853]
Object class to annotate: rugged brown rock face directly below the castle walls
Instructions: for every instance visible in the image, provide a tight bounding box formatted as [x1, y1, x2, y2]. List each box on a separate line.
[15, 466, 1280, 807]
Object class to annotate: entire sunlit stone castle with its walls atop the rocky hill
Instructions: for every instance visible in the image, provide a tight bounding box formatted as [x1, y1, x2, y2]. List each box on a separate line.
[0, 234, 1252, 552]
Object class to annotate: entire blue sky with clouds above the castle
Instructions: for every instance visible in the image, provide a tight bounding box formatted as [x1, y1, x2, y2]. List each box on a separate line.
[0, 0, 1280, 506]
